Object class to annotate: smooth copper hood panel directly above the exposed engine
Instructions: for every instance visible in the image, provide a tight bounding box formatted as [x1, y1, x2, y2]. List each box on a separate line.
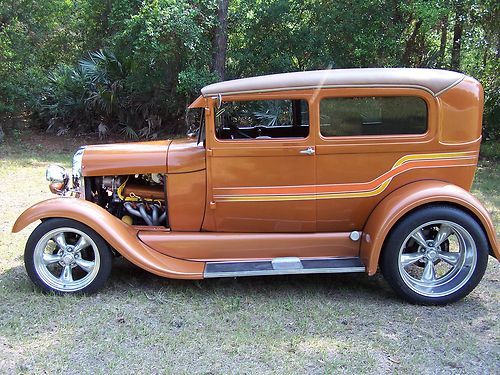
[82, 140, 171, 176]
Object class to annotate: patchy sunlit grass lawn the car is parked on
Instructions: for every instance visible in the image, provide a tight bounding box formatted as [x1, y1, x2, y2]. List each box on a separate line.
[0, 141, 500, 374]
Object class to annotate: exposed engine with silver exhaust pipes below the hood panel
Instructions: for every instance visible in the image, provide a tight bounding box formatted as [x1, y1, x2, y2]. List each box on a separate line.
[86, 173, 168, 226]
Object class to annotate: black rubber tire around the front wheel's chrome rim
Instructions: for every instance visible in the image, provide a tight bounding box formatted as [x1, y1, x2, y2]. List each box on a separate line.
[24, 218, 113, 295]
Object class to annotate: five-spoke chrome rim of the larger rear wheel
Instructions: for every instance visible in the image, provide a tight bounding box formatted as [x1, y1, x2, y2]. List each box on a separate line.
[398, 220, 477, 297]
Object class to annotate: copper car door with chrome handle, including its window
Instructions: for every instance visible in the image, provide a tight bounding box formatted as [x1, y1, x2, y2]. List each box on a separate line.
[204, 93, 316, 233]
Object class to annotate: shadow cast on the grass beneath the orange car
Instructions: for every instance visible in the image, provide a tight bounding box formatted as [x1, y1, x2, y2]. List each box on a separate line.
[0, 258, 494, 314]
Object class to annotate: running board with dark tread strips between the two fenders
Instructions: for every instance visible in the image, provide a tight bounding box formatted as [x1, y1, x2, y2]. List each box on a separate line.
[203, 257, 365, 278]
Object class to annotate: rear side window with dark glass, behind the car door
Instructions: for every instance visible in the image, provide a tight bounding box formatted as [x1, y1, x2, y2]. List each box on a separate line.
[320, 96, 427, 137]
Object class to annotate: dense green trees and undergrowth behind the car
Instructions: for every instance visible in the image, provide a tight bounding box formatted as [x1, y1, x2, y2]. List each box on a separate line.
[0, 0, 500, 138]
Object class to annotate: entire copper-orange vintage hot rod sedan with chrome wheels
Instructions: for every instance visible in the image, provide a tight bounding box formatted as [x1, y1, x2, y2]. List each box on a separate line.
[13, 69, 500, 304]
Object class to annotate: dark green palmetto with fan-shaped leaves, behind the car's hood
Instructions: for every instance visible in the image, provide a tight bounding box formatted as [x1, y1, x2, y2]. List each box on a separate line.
[39, 50, 166, 139]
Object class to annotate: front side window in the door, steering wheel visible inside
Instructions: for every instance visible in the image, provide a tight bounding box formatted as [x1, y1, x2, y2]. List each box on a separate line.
[215, 99, 309, 140]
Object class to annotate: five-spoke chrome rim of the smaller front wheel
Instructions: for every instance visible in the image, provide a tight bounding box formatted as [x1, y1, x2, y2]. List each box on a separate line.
[33, 227, 101, 292]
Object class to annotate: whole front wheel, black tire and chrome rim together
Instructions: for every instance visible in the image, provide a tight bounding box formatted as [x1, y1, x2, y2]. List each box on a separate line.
[24, 218, 113, 294]
